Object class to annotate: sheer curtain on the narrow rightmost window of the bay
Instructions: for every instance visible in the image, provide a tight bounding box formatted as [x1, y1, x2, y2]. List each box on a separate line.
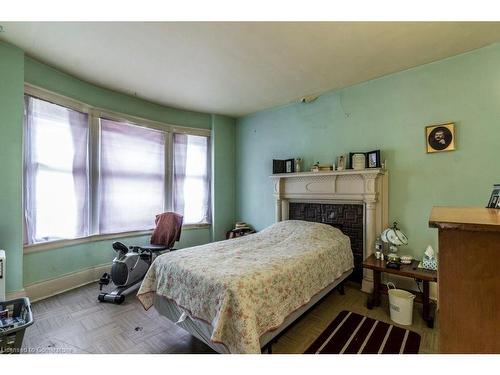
[173, 133, 211, 224]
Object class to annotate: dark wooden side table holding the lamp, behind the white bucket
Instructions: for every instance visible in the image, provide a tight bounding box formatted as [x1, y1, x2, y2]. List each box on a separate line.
[363, 254, 438, 328]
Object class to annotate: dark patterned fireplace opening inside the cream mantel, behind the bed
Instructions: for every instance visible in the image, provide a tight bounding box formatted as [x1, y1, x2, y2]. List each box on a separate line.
[288, 202, 364, 283]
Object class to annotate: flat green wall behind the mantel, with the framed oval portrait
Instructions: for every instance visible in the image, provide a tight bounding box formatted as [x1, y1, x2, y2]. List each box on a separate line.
[236, 44, 500, 257]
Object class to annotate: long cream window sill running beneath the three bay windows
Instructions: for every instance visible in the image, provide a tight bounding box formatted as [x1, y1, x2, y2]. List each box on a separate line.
[23, 223, 212, 254]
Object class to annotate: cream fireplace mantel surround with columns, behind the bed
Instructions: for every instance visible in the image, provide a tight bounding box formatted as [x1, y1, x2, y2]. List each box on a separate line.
[270, 168, 389, 292]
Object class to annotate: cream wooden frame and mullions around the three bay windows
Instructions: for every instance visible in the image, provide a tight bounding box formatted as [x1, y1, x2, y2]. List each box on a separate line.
[23, 83, 213, 254]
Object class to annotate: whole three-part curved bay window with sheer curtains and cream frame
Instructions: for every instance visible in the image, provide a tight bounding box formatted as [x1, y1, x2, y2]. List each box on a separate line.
[23, 86, 211, 245]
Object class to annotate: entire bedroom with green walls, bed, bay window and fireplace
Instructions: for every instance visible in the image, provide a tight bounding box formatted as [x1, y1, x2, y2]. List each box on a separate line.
[0, 0, 500, 374]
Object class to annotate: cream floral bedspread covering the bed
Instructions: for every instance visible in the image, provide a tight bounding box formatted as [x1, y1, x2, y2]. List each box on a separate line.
[137, 220, 354, 353]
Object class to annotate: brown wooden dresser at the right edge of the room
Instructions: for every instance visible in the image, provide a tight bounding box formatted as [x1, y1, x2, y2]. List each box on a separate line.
[429, 207, 500, 353]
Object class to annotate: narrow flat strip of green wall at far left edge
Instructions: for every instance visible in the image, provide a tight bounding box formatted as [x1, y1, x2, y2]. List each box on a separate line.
[0, 42, 24, 291]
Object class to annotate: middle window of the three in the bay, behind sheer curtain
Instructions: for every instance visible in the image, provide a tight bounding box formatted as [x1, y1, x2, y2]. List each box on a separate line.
[99, 119, 165, 233]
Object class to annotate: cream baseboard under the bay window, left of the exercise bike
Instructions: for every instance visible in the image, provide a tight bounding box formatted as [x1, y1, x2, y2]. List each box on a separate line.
[24, 263, 111, 302]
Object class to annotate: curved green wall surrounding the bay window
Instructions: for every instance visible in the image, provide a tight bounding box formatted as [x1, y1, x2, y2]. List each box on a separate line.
[0, 42, 235, 292]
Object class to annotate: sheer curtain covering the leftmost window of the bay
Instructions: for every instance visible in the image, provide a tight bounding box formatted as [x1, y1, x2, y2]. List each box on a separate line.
[23, 95, 89, 244]
